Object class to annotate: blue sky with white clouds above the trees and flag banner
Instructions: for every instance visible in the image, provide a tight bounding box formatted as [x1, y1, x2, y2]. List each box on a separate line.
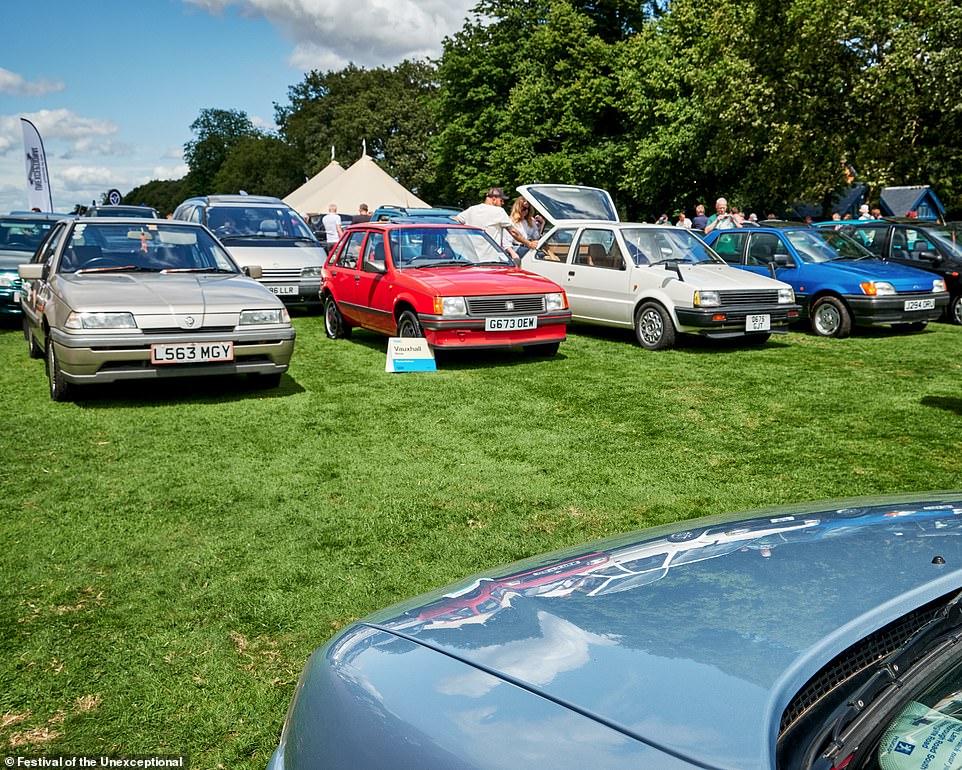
[0, 0, 474, 211]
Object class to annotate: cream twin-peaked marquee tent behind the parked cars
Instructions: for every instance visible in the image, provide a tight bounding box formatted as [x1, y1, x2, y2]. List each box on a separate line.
[284, 154, 429, 214]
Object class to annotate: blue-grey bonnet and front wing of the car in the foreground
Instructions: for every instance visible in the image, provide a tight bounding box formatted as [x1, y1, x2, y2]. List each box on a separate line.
[270, 493, 962, 770]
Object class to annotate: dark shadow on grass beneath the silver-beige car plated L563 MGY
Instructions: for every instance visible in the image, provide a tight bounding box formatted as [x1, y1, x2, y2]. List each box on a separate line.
[73, 374, 304, 409]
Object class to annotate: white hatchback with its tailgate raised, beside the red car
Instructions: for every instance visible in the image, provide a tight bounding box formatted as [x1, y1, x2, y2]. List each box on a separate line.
[518, 185, 799, 350]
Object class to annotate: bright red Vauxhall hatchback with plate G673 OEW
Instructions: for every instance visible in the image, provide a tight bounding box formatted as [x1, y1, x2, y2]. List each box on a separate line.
[321, 222, 571, 355]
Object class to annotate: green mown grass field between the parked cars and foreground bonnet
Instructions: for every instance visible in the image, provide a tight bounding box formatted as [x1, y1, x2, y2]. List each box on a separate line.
[0, 316, 962, 769]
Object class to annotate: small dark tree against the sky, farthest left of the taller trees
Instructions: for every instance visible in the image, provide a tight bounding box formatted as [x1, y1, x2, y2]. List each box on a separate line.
[184, 109, 262, 197]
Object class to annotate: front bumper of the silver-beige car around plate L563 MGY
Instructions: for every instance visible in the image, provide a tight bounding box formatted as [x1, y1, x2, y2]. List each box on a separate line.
[48, 327, 295, 385]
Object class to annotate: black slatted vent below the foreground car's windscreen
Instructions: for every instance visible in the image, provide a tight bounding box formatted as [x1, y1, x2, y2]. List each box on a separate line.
[778, 592, 955, 735]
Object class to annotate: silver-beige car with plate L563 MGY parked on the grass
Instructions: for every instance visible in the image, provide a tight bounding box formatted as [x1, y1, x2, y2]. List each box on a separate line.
[18, 218, 295, 401]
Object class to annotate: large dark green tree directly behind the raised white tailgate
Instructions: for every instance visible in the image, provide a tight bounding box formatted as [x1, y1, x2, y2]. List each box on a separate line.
[434, 0, 636, 203]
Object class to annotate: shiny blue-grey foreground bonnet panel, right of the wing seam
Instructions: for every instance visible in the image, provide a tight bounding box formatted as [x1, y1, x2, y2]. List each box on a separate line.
[354, 493, 962, 770]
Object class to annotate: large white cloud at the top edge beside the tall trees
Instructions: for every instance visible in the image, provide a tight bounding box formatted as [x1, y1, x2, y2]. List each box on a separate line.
[184, 0, 476, 70]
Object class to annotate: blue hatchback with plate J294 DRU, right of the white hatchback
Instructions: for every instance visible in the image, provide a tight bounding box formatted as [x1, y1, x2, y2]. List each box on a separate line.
[705, 223, 949, 337]
